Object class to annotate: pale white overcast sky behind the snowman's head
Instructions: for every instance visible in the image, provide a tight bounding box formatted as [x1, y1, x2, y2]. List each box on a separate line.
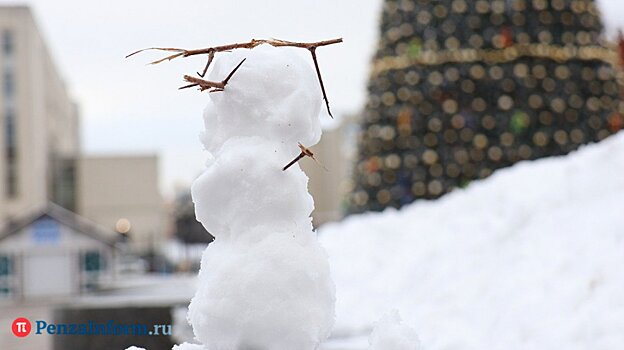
[0, 0, 624, 195]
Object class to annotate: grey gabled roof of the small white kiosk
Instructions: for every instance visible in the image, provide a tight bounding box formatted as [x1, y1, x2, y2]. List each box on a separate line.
[0, 202, 118, 246]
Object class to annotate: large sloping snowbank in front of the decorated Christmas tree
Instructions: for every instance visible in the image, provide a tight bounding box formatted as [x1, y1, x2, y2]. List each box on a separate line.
[319, 132, 624, 350]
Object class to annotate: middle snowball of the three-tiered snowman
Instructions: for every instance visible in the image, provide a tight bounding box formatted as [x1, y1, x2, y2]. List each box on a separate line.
[191, 136, 314, 240]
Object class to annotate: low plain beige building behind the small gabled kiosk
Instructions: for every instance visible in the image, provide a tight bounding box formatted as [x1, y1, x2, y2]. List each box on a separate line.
[76, 155, 169, 253]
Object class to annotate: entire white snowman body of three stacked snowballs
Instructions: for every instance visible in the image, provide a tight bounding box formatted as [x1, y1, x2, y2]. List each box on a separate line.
[178, 45, 335, 350]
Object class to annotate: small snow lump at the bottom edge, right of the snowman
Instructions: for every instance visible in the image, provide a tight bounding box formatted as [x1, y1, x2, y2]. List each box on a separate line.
[368, 310, 420, 350]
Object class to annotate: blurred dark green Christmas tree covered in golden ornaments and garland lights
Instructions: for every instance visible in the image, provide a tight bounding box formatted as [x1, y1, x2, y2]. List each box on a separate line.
[349, 0, 624, 212]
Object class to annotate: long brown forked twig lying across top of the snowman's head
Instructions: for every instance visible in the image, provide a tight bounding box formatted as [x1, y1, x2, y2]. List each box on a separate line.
[126, 38, 342, 118]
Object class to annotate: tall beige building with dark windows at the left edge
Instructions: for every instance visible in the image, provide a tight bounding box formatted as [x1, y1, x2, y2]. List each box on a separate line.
[0, 6, 80, 223]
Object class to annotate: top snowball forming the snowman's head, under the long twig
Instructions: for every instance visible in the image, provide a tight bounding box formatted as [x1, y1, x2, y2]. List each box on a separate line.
[201, 44, 322, 156]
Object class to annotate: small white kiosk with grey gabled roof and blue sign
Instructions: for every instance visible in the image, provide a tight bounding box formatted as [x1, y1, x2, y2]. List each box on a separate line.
[0, 203, 117, 299]
